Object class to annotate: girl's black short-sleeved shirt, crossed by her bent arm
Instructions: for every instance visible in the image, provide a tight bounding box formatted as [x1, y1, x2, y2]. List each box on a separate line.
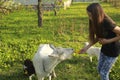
[101, 18, 120, 57]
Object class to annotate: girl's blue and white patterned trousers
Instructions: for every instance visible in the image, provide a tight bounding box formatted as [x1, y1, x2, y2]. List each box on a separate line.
[98, 52, 117, 80]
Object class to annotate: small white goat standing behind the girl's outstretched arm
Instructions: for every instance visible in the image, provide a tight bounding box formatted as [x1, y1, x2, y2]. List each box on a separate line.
[85, 42, 101, 62]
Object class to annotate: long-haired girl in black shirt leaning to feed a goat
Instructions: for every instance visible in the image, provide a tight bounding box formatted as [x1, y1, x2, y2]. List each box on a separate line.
[79, 3, 120, 80]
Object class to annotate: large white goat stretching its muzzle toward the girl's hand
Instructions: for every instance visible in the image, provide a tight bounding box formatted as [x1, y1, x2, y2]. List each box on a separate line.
[33, 44, 73, 80]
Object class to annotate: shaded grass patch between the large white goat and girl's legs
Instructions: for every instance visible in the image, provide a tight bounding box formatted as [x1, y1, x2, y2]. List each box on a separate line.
[54, 56, 99, 80]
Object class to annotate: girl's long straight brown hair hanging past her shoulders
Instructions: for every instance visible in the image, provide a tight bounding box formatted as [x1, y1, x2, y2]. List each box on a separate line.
[87, 3, 115, 43]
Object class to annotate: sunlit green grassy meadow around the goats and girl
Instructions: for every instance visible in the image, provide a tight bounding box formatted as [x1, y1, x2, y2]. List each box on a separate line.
[0, 3, 120, 80]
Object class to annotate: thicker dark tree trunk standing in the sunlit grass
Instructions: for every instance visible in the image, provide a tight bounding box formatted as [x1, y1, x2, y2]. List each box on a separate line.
[37, 0, 43, 27]
